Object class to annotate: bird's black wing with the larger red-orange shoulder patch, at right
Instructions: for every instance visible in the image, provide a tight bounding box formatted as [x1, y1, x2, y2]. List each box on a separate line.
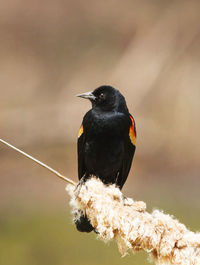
[118, 115, 136, 188]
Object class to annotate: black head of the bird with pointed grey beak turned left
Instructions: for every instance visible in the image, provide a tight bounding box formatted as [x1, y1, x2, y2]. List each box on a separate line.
[77, 86, 126, 111]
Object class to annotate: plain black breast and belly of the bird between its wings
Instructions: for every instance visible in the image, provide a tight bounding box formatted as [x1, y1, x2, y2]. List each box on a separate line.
[83, 112, 129, 177]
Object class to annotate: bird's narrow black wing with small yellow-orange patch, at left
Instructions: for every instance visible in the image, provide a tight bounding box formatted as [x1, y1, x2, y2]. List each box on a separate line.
[78, 124, 86, 180]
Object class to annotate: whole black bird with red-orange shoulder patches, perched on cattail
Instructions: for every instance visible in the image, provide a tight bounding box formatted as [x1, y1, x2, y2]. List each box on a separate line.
[76, 86, 136, 232]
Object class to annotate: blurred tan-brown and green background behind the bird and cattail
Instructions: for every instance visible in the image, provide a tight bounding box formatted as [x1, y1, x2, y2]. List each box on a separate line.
[0, 0, 200, 265]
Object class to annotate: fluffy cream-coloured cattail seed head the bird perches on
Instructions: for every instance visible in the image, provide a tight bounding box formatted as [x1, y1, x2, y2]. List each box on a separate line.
[66, 178, 200, 265]
